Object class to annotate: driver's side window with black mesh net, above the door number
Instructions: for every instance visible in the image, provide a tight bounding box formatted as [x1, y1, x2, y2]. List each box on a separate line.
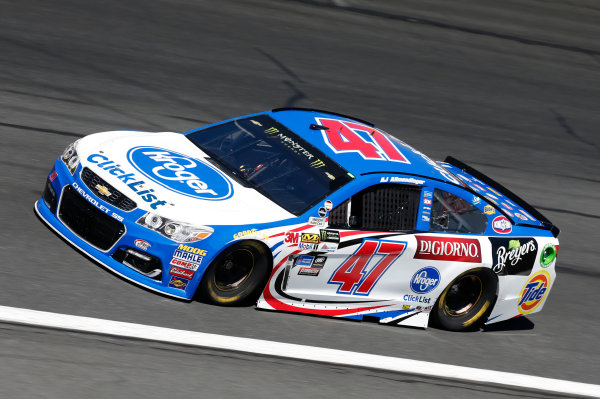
[329, 184, 421, 231]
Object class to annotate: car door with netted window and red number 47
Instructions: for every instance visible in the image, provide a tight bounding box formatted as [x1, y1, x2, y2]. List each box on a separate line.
[282, 183, 422, 301]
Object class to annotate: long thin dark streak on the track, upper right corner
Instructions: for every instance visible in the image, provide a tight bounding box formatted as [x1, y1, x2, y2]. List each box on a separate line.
[293, 0, 600, 56]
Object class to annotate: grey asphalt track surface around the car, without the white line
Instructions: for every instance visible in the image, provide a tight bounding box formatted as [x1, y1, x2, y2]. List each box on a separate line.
[0, 0, 600, 398]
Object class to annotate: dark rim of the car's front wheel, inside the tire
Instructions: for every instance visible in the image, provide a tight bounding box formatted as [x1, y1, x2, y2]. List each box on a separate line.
[214, 249, 254, 291]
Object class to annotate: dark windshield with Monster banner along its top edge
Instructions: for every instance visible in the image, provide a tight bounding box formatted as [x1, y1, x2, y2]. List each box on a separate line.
[187, 115, 354, 215]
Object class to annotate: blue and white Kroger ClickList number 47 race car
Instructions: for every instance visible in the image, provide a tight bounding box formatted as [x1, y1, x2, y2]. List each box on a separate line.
[35, 108, 559, 331]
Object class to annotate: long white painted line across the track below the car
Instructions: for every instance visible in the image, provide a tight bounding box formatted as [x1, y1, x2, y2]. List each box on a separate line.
[0, 306, 600, 398]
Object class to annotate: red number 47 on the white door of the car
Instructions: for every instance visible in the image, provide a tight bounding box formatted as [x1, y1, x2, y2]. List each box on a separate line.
[327, 240, 406, 295]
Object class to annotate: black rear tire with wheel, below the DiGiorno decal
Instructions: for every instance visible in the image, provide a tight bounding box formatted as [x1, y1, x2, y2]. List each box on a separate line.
[431, 268, 498, 331]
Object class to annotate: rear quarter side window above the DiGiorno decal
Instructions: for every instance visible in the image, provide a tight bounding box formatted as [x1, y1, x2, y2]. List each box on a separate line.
[429, 188, 487, 234]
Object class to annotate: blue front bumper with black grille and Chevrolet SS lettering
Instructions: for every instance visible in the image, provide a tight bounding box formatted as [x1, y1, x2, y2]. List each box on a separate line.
[34, 160, 213, 300]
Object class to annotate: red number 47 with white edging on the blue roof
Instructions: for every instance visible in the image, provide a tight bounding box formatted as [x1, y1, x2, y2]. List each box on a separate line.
[316, 118, 410, 163]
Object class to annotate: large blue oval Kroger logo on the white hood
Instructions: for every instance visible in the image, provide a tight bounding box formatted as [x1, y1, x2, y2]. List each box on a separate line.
[127, 147, 233, 201]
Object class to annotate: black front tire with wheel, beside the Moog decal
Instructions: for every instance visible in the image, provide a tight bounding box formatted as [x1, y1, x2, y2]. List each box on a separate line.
[200, 241, 271, 306]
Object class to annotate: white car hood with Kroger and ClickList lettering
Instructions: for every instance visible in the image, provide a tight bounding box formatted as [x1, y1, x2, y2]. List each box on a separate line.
[77, 131, 294, 225]
